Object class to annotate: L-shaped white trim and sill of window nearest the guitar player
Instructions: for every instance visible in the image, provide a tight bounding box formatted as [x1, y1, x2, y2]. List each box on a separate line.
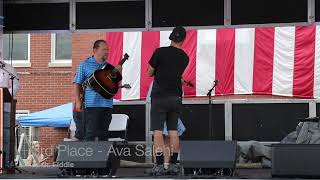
[49, 33, 72, 67]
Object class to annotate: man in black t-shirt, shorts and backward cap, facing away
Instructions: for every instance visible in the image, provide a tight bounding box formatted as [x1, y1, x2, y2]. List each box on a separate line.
[148, 27, 189, 176]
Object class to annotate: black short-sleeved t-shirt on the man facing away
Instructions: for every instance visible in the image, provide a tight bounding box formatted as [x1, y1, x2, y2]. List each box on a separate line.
[149, 46, 189, 97]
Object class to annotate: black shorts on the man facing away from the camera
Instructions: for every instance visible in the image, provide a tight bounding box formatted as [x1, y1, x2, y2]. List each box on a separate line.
[151, 97, 182, 131]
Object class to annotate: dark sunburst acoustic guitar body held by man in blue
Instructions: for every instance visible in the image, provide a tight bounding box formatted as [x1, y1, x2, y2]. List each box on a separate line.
[88, 64, 122, 99]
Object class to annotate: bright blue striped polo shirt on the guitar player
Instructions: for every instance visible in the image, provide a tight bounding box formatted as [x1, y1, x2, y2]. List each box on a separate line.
[73, 56, 113, 108]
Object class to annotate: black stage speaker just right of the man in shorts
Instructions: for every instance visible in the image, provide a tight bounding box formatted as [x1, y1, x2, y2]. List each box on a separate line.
[180, 141, 237, 176]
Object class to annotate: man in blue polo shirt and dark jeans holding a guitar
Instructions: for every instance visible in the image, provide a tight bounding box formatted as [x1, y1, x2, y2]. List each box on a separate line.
[73, 40, 121, 141]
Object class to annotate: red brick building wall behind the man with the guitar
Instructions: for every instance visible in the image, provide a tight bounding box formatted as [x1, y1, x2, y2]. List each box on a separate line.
[16, 33, 105, 162]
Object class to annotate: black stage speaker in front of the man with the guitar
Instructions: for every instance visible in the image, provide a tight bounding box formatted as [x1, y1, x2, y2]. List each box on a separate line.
[56, 141, 120, 175]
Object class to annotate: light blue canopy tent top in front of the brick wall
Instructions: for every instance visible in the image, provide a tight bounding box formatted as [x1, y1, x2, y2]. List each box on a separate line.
[17, 103, 73, 127]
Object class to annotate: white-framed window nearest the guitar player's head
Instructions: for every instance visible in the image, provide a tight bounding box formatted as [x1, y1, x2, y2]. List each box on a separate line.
[49, 33, 72, 67]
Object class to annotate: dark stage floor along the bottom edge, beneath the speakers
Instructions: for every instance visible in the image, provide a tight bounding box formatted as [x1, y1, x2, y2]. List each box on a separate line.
[0, 167, 272, 179]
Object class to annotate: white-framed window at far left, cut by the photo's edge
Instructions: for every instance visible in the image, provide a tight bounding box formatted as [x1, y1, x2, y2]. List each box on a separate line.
[3, 34, 30, 65]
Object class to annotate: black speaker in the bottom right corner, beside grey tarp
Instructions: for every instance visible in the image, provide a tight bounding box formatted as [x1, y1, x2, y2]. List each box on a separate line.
[271, 144, 320, 177]
